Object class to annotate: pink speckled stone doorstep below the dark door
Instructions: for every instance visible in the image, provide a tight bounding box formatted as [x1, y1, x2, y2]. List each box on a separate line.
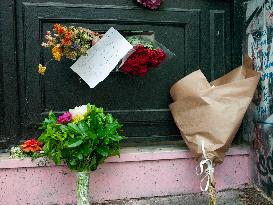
[0, 146, 251, 205]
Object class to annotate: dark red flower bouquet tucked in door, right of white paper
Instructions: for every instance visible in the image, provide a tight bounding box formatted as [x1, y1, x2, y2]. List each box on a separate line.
[120, 36, 170, 76]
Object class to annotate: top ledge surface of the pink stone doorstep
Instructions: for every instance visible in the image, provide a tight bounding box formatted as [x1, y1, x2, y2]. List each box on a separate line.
[0, 145, 250, 169]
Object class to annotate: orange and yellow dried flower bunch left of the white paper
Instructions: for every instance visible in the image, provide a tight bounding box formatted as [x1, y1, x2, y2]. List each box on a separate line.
[38, 24, 101, 75]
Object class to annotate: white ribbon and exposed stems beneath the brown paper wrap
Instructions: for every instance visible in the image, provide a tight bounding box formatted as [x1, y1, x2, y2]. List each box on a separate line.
[196, 141, 216, 205]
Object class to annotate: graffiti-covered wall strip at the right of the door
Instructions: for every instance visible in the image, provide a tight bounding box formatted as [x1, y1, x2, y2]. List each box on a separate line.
[246, 0, 273, 196]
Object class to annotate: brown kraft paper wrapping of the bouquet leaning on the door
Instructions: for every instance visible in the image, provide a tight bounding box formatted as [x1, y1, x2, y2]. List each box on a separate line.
[170, 66, 260, 164]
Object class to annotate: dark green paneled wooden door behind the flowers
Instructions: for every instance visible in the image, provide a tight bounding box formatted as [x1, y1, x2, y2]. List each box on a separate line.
[2, 0, 241, 147]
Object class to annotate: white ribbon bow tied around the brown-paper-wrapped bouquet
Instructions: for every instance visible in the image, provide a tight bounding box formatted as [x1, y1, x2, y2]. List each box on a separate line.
[196, 141, 214, 191]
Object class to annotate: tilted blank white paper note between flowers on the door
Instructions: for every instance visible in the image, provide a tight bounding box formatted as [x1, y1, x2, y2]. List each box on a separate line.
[71, 27, 133, 88]
